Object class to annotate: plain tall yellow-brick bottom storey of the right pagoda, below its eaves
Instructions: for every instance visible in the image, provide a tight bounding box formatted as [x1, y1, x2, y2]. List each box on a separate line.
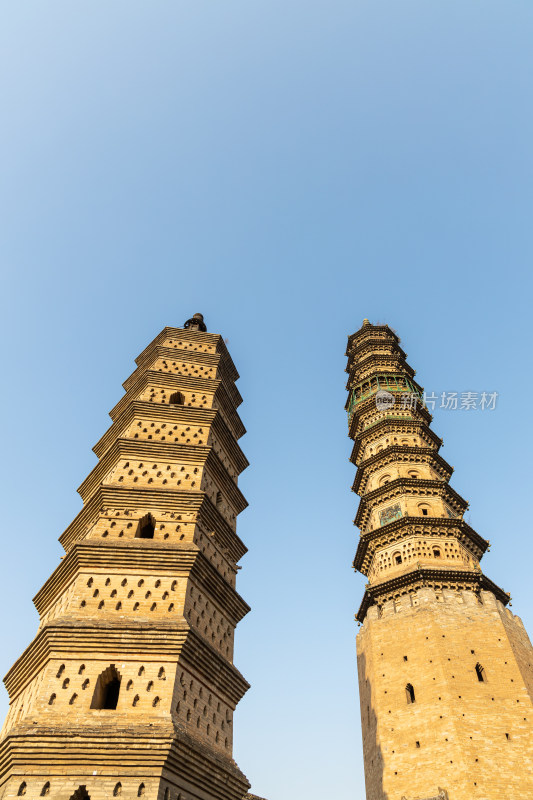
[357, 588, 533, 800]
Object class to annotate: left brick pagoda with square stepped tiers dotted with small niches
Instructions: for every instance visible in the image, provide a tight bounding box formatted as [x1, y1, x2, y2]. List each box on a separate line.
[0, 315, 256, 800]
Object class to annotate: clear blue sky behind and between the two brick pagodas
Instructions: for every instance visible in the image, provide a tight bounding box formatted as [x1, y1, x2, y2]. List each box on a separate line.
[0, 0, 533, 800]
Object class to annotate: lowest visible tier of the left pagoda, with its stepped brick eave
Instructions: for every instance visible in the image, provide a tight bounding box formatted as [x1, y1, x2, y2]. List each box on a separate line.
[0, 724, 250, 800]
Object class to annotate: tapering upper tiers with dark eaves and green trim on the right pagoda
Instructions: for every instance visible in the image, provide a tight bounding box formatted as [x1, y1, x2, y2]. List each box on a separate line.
[347, 319, 502, 622]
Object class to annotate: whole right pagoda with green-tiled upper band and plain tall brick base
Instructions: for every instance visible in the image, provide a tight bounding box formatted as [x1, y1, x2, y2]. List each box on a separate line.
[346, 320, 533, 800]
